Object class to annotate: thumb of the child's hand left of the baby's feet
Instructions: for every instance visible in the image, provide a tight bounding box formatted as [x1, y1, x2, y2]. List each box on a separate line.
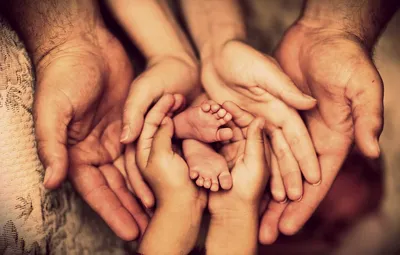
[151, 117, 174, 155]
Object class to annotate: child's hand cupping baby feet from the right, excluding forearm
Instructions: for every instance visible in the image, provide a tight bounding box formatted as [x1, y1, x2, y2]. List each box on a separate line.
[208, 105, 269, 214]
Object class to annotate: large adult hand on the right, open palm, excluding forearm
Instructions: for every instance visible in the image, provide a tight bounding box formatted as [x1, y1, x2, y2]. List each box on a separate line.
[260, 22, 383, 243]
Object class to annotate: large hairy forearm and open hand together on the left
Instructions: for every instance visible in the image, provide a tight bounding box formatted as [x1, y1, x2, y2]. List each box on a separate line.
[2, 0, 148, 240]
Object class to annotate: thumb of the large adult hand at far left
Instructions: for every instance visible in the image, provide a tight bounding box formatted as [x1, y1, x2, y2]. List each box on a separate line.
[34, 90, 72, 189]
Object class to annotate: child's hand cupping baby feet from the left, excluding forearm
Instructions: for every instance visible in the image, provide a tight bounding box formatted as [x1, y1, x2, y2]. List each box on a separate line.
[136, 95, 207, 207]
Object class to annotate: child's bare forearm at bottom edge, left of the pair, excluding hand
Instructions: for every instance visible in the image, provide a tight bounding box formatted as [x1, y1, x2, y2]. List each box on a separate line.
[139, 204, 203, 255]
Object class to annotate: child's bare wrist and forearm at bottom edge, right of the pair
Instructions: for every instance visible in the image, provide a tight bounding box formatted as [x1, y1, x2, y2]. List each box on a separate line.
[206, 208, 259, 254]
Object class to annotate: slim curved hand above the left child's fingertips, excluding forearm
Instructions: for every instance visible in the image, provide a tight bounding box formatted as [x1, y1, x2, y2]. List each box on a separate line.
[121, 56, 200, 144]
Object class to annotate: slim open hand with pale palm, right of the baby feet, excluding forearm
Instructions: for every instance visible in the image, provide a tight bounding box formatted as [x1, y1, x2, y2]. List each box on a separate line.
[202, 41, 321, 201]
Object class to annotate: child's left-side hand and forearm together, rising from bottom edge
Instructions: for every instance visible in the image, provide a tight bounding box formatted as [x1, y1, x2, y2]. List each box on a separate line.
[137, 95, 207, 254]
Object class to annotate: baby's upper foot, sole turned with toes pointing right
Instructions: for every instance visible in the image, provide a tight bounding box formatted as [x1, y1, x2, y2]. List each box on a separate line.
[173, 100, 233, 143]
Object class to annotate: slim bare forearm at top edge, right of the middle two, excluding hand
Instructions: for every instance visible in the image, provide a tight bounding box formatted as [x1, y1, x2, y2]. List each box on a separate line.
[181, 0, 246, 57]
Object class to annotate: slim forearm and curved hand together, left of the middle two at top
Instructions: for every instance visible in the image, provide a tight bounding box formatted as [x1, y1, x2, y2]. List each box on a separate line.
[105, 0, 200, 208]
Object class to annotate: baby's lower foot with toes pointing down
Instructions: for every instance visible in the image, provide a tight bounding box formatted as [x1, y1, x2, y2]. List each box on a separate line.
[182, 139, 232, 191]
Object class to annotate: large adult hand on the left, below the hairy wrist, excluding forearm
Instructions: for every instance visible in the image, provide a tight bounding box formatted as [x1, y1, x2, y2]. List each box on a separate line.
[34, 28, 147, 240]
